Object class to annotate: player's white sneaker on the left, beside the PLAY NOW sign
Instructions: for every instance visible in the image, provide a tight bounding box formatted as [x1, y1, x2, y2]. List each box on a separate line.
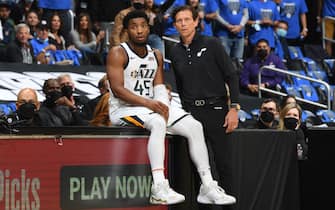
[150, 179, 185, 205]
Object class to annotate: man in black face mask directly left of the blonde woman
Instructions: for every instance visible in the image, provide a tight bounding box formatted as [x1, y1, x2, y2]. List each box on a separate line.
[254, 98, 279, 129]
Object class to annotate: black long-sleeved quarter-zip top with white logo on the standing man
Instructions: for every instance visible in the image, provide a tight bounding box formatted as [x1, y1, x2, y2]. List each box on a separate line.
[170, 33, 239, 103]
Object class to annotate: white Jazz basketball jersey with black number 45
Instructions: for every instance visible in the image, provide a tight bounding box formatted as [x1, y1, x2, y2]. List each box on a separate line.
[121, 43, 158, 98]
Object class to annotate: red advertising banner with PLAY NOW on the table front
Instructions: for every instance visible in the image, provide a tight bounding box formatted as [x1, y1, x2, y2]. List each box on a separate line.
[0, 136, 167, 210]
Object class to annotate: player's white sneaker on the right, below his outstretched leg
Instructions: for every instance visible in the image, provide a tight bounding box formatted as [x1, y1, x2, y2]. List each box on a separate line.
[197, 181, 236, 205]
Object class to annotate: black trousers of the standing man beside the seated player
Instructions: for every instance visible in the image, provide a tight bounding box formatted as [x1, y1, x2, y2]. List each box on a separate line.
[184, 101, 232, 209]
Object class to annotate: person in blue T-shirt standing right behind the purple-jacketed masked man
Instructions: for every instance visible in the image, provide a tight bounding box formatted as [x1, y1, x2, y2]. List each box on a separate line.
[247, 0, 280, 54]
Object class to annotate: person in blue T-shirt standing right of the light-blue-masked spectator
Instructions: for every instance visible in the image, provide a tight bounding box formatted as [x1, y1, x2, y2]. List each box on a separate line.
[280, 0, 308, 46]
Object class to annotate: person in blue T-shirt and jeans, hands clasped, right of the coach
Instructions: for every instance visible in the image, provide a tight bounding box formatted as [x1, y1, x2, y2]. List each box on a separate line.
[215, 0, 249, 59]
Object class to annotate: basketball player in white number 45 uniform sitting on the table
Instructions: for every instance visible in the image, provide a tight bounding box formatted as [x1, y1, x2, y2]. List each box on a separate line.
[107, 10, 236, 205]
